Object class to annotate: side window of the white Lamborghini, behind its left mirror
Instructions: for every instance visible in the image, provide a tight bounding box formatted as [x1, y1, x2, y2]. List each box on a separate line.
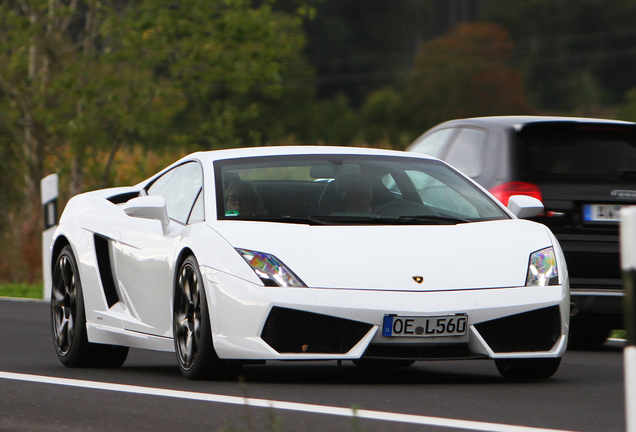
[147, 162, 203, 224]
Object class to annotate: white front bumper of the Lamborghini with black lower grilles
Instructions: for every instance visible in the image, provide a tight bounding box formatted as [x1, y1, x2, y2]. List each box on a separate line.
[202, 268, 570, 360]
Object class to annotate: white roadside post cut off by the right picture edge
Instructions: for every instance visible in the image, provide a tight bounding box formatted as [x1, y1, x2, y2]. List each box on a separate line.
[620, 207, 636, 432]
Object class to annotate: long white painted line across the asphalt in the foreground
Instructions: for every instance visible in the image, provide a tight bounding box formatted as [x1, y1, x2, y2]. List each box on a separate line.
[0, 372, 571, 432]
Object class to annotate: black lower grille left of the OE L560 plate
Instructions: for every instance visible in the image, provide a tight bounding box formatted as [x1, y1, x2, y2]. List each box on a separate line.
[261, 307, 373, 354]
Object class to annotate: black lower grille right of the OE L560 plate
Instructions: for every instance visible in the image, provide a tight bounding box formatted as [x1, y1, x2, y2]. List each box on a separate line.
[475, 306, 561, 353]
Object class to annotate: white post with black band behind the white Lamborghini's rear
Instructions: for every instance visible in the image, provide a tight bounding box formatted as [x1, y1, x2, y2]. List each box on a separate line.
[40, 174, 58, 300]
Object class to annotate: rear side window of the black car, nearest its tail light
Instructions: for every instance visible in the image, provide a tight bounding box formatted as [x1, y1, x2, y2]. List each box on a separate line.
[444, 128, 486, 177]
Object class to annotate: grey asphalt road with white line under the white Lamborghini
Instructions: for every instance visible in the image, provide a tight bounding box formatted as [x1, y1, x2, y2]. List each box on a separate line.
[0, 299, 625, 432]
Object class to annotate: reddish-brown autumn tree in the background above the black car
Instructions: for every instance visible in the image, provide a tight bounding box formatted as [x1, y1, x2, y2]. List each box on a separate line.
[403, 24, 530, 134]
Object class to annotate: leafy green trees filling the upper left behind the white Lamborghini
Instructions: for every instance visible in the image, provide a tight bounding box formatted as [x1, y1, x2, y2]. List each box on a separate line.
[0, 0, 312, 277]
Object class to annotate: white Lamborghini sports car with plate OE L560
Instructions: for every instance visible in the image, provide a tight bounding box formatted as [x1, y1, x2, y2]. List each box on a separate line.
[51, 146, 570, 379]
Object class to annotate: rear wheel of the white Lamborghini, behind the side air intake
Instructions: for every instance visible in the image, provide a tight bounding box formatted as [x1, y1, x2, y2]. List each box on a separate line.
[51, 245, 128, 368]
